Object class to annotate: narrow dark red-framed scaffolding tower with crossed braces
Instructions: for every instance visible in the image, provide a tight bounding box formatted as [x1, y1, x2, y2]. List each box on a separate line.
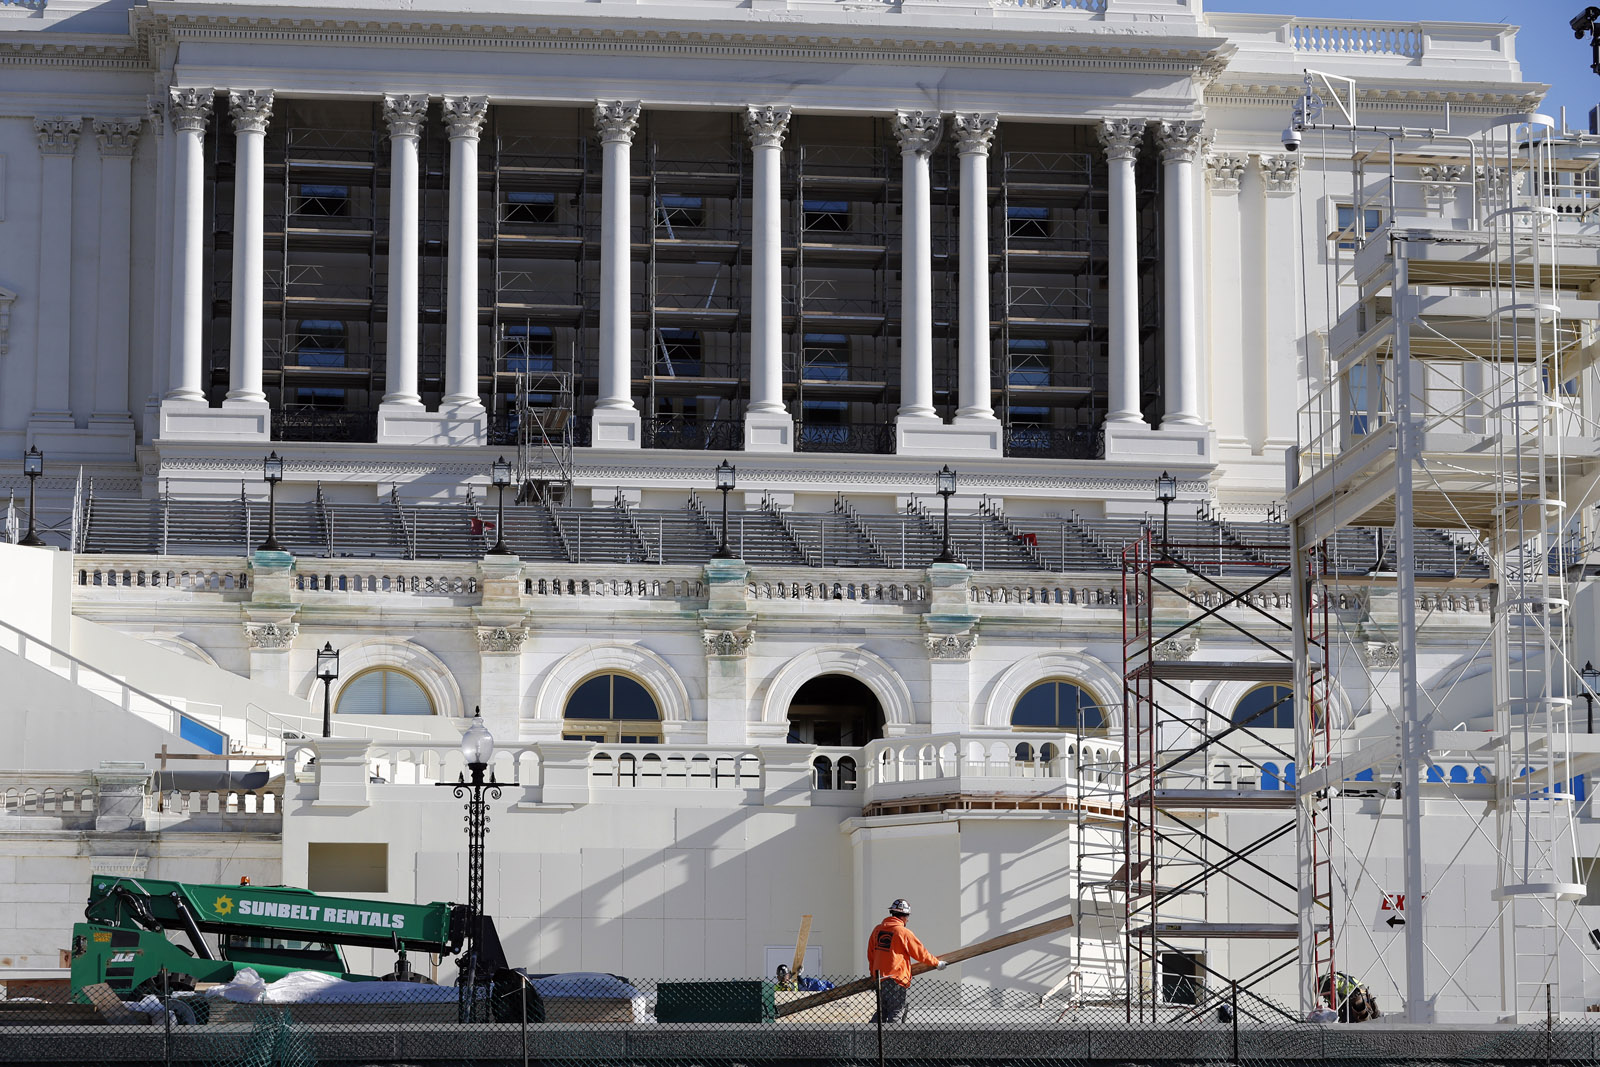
[1118, 523, 1328, 1022]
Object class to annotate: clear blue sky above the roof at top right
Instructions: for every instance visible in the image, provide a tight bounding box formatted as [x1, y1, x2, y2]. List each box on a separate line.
[1205, 0, 1600, 130]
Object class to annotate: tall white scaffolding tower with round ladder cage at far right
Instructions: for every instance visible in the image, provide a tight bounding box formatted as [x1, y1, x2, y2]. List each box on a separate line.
[1288, 81, 1600, 1022]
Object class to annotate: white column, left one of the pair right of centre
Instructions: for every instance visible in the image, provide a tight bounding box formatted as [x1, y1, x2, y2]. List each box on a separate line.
[894, 110, 942, 419]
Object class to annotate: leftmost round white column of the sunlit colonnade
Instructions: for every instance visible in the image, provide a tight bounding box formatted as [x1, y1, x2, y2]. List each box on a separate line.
[166, 88, 216, 400]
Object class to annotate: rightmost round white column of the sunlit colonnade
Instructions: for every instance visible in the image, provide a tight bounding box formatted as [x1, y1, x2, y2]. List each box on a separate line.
[1155, 122, 1203, 430]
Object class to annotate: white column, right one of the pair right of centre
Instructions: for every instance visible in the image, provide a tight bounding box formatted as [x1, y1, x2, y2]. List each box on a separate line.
[950, 112, 1000, 422]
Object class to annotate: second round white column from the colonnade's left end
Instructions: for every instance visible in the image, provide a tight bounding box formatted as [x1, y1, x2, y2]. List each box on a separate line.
[224, 90, 272, 406]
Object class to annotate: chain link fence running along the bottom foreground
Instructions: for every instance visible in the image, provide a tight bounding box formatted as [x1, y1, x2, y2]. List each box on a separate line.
[0, 971, 1600, 1067]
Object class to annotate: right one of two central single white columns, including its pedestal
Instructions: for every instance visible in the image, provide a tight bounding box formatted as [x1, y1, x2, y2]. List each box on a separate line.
[744, 107, 794, 451]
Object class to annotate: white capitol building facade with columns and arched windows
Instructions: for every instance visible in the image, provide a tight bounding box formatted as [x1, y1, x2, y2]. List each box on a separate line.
[0, 0, 1600, 1019]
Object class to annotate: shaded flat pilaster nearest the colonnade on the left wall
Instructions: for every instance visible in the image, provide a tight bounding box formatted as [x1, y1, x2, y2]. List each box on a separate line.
[90, 118, 144, 432]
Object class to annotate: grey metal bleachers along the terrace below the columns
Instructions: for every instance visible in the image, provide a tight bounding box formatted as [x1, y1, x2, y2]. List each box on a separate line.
[68, 496, 1490, 579]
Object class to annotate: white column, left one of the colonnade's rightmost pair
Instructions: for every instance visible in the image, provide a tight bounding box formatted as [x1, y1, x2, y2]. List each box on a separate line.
[1099, 118, 1144, 422]
